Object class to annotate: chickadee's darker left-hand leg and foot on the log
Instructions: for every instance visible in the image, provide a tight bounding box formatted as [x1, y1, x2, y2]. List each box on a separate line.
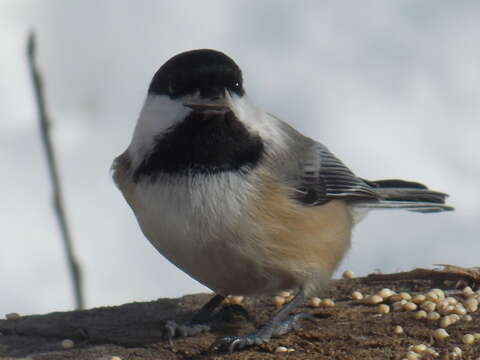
[163, 295, 225, 347]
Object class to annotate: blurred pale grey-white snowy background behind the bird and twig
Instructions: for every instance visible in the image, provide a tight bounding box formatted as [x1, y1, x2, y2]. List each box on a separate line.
[0, 0, 480, 314]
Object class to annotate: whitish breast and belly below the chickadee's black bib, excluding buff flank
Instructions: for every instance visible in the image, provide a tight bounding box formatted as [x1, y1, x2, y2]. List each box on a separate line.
[130, 173, 284, 294]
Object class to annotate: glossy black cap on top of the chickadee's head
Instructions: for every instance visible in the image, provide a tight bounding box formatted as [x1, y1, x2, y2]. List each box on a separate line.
[148, 49, 245, 99]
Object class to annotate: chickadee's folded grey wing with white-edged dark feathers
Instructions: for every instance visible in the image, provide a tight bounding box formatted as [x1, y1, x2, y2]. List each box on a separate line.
[296, 142, 379, 205]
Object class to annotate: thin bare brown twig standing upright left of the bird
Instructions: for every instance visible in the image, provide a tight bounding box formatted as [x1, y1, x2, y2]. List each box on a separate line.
[27, 32, 84, 309]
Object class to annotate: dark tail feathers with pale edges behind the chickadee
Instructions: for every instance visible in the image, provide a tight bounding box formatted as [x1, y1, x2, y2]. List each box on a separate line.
[359, 179, 453, 213]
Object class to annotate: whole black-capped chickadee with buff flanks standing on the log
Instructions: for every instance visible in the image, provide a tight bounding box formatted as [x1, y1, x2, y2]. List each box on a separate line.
[112, 49, 453, 352]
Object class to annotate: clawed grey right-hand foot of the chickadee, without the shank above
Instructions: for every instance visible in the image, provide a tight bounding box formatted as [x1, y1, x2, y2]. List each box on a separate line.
[210, 313, 316, 353]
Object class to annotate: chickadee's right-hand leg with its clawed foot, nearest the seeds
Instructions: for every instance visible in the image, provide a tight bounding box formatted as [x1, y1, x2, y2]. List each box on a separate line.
[211, 289, 315, 352]
